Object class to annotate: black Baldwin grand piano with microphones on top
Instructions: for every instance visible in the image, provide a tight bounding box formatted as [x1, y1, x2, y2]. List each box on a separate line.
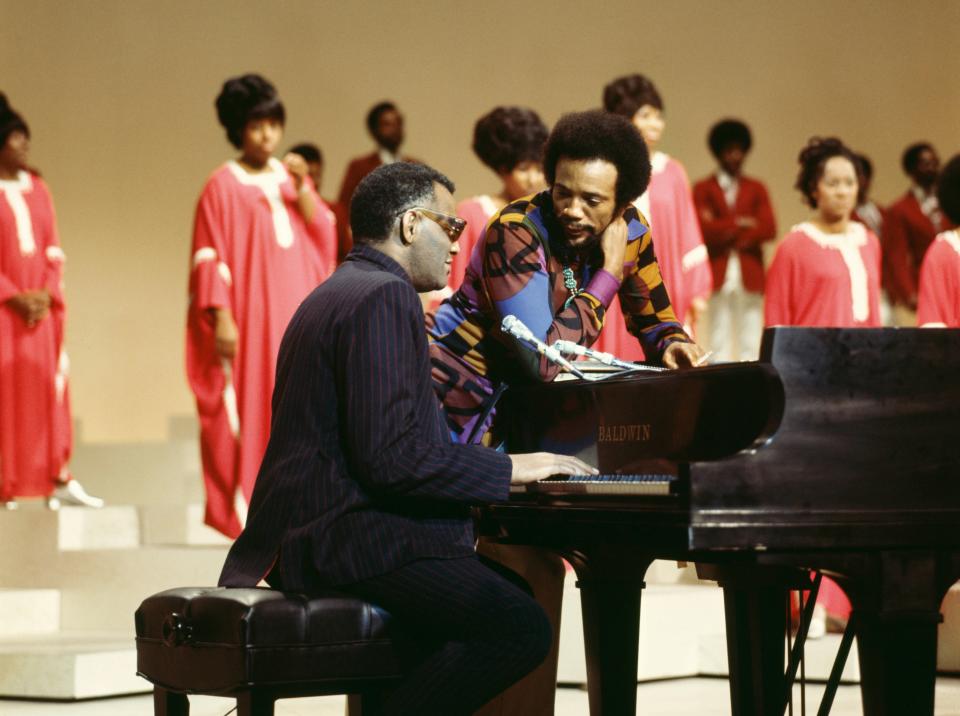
[480, 328, 960, 716]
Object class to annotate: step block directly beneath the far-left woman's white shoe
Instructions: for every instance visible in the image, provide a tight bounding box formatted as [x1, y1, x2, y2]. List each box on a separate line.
[0, 503, 140, 559]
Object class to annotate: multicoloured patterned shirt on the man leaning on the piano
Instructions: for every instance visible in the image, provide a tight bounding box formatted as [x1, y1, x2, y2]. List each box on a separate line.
[427, 191, 690, 441]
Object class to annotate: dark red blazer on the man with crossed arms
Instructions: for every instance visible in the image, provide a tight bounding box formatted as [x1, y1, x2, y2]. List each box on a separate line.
[693, 176, 777, 293]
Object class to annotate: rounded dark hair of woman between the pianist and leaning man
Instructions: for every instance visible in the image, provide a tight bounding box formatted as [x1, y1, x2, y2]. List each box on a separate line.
[473, 107, 547, 174]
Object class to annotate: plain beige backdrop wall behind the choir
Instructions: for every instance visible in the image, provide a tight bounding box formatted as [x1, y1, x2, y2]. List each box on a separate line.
[0, 0, 960, 441]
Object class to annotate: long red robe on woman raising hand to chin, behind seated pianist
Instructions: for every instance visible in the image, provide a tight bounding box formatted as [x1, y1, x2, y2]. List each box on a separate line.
[187, 159, 337, 537]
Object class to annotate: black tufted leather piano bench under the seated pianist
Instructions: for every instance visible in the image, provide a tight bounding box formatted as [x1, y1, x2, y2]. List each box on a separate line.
[136, 587, 411, 716]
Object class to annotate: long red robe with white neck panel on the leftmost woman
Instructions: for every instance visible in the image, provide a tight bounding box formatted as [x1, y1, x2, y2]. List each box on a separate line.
[0, 171, 73, 502]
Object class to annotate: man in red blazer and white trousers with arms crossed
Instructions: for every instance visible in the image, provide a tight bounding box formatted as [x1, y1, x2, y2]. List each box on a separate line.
[693, 119, 777, 361]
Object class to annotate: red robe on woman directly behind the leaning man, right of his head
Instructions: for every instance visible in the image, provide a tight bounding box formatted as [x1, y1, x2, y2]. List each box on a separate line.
[593, 152, 713, 360]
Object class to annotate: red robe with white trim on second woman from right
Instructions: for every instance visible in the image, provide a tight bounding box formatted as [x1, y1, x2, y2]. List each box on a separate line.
[764, 221, 881, 620]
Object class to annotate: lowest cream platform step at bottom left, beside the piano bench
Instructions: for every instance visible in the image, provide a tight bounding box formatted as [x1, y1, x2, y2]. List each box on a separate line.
[0, 632, 144, 699]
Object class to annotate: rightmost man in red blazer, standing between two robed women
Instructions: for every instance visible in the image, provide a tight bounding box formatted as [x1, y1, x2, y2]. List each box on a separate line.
[883, 142, 950, 326]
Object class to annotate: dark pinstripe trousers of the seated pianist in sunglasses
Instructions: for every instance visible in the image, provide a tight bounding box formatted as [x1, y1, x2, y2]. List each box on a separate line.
[340, 556, 552, 716]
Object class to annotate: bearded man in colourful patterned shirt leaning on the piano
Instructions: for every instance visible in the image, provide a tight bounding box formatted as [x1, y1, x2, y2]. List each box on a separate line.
[427, 111, 703, 714]
